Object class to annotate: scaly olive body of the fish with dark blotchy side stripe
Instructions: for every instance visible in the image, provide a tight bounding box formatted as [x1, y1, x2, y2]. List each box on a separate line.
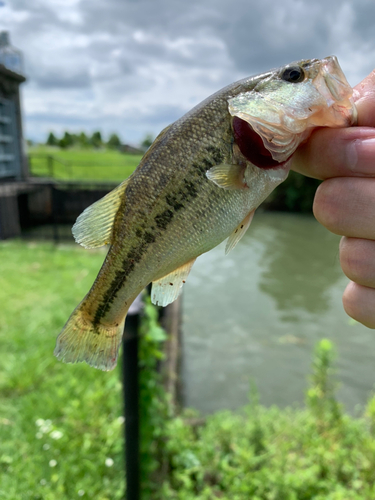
[87, 86, 254, 322]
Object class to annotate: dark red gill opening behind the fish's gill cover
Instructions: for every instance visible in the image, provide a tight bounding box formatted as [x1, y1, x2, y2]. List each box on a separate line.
[233, 116, 292, 169]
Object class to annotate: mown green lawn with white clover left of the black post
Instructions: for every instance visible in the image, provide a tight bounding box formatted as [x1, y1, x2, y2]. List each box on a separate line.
[0, 242, 124, 500]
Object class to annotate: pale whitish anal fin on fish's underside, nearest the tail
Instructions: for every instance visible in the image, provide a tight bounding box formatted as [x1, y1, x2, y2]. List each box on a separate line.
[151, 259, 195, 307]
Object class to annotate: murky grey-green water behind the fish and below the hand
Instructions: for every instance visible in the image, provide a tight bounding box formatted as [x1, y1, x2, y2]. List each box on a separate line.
[182, 213, 375, 413]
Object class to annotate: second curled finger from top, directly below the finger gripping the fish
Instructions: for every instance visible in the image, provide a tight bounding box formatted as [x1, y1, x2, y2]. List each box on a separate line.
[313, 177, 375, 240]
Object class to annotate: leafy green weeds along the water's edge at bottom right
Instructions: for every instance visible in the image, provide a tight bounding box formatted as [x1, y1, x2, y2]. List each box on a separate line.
[150, 340, 375, 500]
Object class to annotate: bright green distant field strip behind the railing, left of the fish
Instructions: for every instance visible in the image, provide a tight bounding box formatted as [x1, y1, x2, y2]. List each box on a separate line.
[28, 146, 142, 182]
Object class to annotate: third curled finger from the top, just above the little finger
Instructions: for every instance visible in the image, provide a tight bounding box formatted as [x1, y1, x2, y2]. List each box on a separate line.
[340, 237, 375, 288]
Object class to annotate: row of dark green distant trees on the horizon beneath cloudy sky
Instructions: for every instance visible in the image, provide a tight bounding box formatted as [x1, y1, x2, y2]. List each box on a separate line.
[46, 130, 153, 151]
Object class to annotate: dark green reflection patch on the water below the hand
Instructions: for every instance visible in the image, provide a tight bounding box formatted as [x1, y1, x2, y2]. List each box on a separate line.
[253, 214, 342, 314]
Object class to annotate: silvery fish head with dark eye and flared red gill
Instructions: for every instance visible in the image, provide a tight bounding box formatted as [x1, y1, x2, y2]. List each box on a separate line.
[228, 56, 357, 169]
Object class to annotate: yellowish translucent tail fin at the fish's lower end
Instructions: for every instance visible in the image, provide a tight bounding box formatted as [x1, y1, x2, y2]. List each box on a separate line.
[54, 305, 125, 371]
